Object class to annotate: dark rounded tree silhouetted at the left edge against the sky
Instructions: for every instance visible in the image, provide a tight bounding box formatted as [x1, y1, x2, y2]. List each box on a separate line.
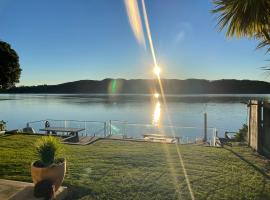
[0, 41, 22, 89]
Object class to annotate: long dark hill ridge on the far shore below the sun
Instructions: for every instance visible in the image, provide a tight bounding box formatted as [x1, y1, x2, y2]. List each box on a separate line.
[1, 79, 270, 94]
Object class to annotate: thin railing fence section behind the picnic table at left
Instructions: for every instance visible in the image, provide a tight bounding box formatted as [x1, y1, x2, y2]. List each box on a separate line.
[26, 119, 106, 137]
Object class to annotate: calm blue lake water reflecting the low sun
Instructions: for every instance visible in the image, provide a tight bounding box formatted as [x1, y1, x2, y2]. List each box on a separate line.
[0, 94, 270, 137]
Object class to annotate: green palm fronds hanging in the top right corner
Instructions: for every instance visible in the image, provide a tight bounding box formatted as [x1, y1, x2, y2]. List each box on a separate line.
[212, 0, 270, 52]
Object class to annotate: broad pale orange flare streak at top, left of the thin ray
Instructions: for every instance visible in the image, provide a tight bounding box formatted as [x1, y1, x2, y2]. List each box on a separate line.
[124, 0, 145, 47]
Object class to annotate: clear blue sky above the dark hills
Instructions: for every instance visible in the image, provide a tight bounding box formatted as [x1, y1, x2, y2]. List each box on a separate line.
[0, 0, 269, 85]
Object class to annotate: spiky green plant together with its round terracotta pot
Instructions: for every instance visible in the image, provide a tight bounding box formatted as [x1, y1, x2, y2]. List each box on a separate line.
[31, 136, 66, 192]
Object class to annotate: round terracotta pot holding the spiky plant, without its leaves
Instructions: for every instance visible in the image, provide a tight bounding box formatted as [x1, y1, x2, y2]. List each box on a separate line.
[31, 159, 66, 192]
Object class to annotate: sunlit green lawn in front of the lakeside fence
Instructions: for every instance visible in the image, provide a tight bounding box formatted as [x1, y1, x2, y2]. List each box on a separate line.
[0, 135, 270, 200]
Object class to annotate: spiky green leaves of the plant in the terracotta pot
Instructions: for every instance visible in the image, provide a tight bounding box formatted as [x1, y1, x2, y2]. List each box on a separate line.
[35, 136, 63, 166]
